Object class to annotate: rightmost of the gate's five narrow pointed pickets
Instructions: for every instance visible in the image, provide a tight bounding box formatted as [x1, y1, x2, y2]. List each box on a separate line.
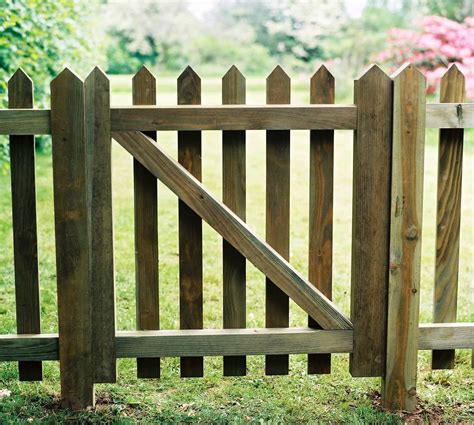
[308, 65, 335, 374]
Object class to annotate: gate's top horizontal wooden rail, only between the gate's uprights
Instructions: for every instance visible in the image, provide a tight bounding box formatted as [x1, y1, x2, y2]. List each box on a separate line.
[111, 105, 357, 131]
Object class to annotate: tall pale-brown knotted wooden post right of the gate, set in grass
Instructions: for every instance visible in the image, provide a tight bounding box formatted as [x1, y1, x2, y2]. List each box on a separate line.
[382, 65, 426, 411]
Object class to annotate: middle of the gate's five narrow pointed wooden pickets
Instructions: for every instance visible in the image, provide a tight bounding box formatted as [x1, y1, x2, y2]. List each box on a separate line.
[222, 66, 246, 376]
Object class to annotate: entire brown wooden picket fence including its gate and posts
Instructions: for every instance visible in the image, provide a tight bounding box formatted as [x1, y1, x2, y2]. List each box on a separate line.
[0, 65, 474, 410]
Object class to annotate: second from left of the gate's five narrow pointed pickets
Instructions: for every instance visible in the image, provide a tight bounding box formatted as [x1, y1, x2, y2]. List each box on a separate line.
[178, 66, 204, 377]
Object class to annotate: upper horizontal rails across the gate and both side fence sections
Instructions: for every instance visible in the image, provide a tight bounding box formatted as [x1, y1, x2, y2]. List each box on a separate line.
[0, 103, 474, 135]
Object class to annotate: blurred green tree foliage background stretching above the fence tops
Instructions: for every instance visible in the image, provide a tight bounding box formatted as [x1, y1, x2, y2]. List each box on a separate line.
[0, 0, 474, 169]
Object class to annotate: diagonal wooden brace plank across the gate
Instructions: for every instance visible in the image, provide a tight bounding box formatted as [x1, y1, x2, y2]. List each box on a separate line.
[112, 132, 352, 329]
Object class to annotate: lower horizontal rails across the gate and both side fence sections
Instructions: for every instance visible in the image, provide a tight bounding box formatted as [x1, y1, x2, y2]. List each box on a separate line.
[0, 323, 474, 361]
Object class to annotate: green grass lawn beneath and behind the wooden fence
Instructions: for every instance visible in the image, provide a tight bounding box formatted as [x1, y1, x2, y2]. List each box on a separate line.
[0, 76, 474, 423]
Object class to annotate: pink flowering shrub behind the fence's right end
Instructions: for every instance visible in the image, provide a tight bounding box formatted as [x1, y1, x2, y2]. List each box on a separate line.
[377, 16, 474, 99]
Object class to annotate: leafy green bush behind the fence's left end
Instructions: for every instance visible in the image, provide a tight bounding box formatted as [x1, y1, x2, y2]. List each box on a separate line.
[0, 0, 100, 166]
